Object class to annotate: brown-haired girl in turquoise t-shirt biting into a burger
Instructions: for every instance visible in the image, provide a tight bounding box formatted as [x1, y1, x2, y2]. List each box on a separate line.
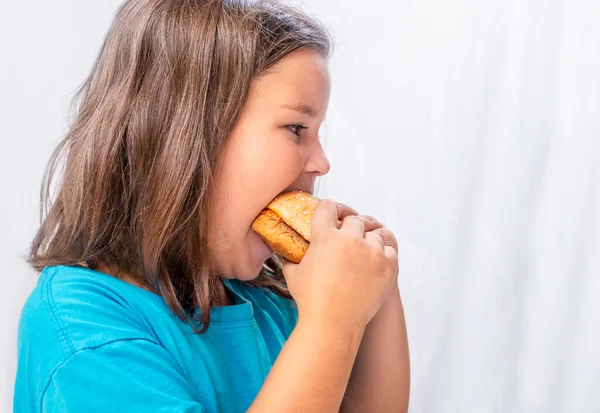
[14, 0, 409, 413]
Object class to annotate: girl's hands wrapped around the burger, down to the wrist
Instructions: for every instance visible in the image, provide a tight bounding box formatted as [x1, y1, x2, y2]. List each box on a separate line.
[283, 200, 398, 329]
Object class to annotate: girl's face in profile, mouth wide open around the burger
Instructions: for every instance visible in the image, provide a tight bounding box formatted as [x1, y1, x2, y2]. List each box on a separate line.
[209, 49, 330, 280]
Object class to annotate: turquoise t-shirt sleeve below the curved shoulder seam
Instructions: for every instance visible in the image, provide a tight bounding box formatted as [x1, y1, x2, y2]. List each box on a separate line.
[41, 339, 205, 413]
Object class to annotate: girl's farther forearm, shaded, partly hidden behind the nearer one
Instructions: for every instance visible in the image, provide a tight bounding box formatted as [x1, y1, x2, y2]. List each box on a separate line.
[342, 288, 410, 413]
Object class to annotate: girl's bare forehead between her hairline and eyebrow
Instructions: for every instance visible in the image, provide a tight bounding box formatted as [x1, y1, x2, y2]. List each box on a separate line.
[248, 49, 331, 111]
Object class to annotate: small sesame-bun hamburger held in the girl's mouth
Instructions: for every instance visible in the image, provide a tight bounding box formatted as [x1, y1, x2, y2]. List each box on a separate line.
[252, 191, 319, 264]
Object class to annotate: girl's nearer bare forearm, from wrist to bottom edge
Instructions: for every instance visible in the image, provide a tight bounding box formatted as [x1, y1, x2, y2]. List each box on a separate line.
[248, 320, 363, 413]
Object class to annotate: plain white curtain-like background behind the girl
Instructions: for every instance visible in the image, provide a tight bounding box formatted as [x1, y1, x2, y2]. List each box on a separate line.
[0, 0, 600, 413]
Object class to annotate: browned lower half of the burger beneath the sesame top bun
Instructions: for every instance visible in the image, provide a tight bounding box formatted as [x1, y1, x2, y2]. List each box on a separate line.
[252, 210, 309, 264]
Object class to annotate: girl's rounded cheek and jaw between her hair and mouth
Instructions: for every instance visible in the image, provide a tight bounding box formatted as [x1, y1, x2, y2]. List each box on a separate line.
[209, 133, 303, 275]
